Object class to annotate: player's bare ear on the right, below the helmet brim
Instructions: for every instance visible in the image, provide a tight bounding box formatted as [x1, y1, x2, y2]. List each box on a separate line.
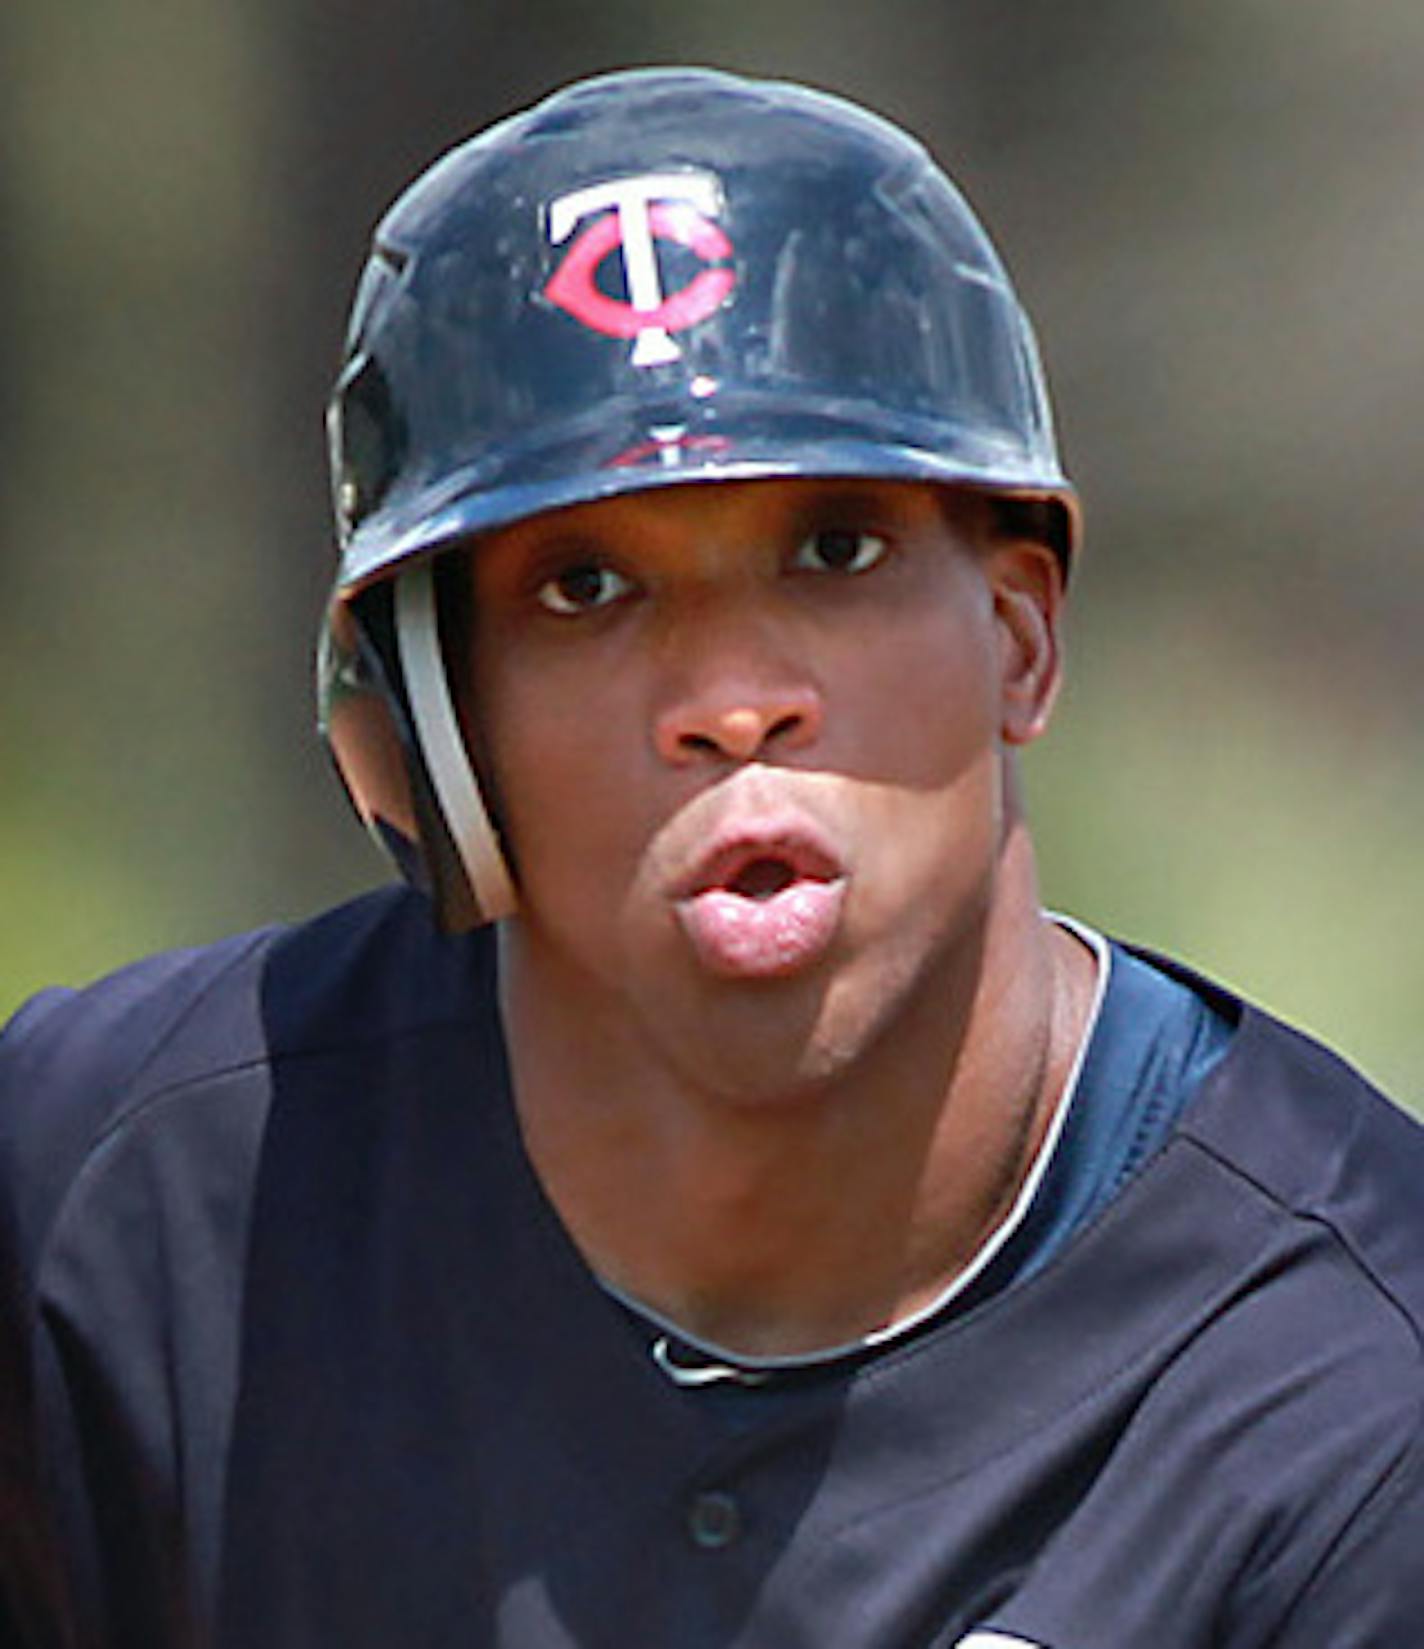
[986, 538, 1063, 745]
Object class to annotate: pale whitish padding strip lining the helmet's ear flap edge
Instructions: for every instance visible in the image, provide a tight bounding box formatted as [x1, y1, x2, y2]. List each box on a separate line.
[396, 561, 519, 922]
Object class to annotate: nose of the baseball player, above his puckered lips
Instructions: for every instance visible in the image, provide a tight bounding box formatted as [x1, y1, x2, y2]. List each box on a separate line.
[653, 637, 824, 767]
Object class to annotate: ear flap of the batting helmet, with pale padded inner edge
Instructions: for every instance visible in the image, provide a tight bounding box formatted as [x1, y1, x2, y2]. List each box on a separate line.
[318, 562, 518, 933]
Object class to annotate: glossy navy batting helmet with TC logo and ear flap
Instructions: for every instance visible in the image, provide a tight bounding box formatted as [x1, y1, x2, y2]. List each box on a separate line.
[320, 69, 1076, 930]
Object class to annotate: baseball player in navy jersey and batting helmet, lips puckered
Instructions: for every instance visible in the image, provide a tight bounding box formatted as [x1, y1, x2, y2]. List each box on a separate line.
[0, 69, 1424, 1649]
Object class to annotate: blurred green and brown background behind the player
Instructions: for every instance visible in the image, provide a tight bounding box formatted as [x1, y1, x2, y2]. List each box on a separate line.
[0, 0, 1424, 1105]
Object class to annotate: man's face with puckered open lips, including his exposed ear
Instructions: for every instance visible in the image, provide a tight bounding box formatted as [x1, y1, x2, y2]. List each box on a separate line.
[466, 480, 1058, 1095]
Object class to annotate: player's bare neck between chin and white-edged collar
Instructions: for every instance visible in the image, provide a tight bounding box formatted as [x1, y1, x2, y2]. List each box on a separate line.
[501, 831, 1093, 1355]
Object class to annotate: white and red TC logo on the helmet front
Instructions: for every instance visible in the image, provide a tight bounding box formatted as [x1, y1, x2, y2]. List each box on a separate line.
[544, 171, 737, 366]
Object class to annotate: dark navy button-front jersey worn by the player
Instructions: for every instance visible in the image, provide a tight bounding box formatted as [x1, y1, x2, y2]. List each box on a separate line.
[0, 892, 1424, 1649]
